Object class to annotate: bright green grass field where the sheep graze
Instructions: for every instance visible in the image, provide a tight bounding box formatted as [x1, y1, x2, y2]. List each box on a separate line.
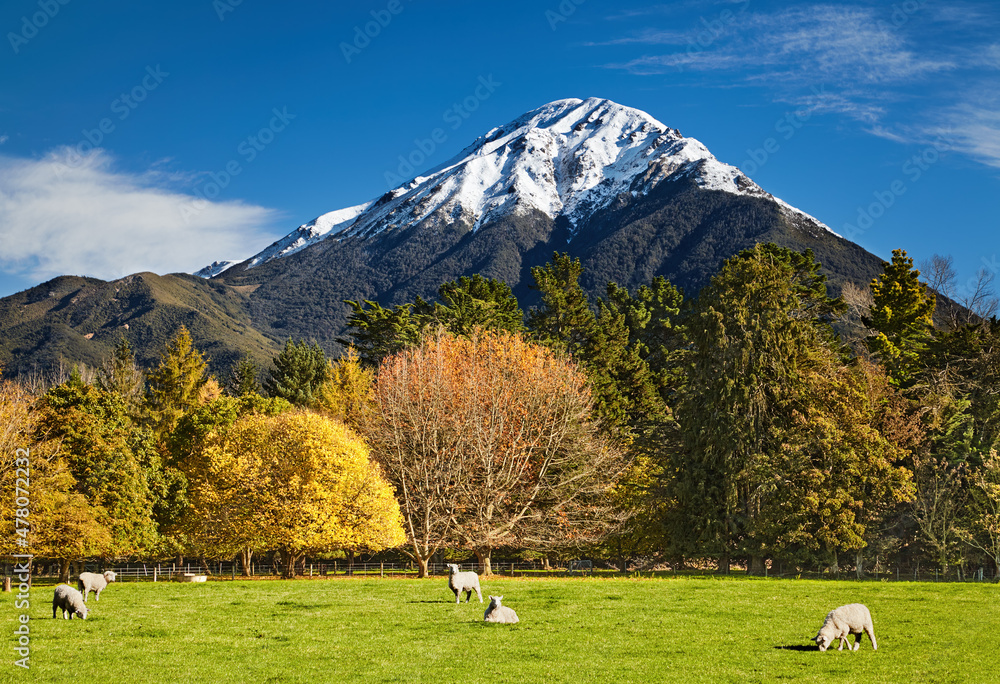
[0, 578, 1000, 684]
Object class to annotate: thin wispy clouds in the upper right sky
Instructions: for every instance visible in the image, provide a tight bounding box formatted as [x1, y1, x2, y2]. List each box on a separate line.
[593, 2, 1000, 167]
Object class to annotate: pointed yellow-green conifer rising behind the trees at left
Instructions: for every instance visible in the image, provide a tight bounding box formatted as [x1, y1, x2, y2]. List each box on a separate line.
[146, 325, 208, 437]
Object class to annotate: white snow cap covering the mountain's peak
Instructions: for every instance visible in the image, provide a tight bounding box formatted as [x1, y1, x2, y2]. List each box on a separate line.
[199, 98, 832, 273]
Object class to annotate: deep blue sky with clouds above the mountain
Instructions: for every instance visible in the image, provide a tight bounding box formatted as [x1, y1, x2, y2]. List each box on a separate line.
[0, 0, 1000, 295]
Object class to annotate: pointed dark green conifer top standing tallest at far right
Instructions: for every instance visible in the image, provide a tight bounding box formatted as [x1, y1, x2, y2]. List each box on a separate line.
[865, 249, 935, 389]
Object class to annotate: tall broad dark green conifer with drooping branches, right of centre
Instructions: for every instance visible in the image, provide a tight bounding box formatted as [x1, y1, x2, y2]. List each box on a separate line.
[671, 244, 844, 572]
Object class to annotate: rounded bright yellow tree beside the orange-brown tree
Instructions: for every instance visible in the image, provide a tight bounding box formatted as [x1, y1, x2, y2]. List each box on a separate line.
[188, 412, 406, 577]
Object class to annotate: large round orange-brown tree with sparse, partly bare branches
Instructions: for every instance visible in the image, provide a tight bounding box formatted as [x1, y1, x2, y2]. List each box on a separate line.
[366, 331, 626, 574]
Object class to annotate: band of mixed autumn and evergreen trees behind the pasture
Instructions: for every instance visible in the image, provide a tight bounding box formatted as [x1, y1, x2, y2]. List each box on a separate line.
[0, 244, 1000, 577]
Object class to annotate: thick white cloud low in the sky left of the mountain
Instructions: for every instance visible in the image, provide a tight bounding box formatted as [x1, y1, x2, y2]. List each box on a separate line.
[0, 149, 277, 279]
